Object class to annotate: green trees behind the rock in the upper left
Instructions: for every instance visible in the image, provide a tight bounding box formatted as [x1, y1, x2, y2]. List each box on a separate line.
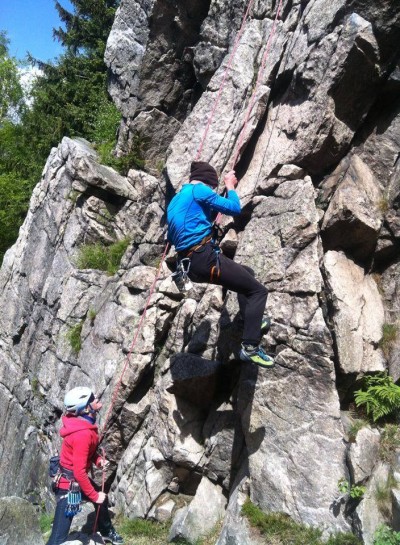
[0, 0, 119, 260]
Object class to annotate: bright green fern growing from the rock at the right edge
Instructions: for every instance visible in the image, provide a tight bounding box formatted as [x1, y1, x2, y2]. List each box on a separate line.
[355, 373, 400, 422]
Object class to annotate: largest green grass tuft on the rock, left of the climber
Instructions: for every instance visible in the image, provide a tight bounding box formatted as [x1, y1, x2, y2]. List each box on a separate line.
[76, 238, 130, 276]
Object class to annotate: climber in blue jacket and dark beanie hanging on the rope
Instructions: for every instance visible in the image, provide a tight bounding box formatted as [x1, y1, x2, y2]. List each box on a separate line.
[167, 161, 274, 368]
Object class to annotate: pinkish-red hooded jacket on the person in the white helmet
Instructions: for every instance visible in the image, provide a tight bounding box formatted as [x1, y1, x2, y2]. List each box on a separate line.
[59, 414, 101, 502]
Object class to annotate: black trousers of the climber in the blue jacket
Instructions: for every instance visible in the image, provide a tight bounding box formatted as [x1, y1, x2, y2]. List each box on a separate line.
[189, 242, 268, 344]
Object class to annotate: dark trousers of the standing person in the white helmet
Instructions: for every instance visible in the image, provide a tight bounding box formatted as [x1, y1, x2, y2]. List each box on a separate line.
[46, 486, 112, 545]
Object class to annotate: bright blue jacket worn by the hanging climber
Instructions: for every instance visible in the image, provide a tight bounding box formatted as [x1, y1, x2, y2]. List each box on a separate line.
[167, 183, 241, 252]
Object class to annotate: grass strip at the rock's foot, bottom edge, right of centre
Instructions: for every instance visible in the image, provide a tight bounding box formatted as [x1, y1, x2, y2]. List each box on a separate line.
[242, 499, 361, 545]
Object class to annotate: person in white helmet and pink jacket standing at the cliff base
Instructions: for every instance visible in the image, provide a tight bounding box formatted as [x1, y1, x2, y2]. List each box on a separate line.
[47, 386, 124, 545]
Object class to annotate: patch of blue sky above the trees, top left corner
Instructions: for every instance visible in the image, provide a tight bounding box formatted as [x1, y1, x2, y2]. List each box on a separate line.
[0, 0, 73, 61]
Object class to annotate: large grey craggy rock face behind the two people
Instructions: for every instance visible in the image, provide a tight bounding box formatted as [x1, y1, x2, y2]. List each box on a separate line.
[0, 0, 400, 545]
